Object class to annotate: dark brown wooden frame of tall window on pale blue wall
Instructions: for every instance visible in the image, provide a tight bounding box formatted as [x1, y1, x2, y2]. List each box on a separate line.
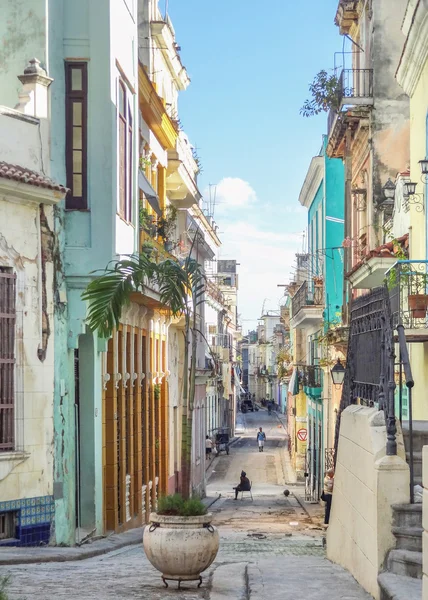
[65, 60, 88, 210]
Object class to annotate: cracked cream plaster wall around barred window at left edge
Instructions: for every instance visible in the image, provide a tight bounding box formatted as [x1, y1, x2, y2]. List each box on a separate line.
[0, 190, 54, 501]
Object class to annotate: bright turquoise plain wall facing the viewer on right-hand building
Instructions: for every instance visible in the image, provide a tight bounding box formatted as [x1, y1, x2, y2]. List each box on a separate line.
[323, 136, 345, 323]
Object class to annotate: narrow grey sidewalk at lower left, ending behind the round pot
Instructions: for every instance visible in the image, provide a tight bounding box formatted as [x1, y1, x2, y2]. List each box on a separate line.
[0, 527, 144, 565]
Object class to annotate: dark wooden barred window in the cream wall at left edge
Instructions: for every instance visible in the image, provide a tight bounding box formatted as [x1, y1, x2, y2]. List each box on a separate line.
[0, 267, 16, 452]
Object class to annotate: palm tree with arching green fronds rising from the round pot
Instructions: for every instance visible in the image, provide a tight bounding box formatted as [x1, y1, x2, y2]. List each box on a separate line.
[82, 253, 205, 498]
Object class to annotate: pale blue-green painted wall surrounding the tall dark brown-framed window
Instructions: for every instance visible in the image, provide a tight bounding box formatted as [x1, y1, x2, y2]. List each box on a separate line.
[47, 0, 138, 544]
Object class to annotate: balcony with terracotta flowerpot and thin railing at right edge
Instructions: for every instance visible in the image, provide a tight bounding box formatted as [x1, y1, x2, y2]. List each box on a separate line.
[386, 260, 428, 342]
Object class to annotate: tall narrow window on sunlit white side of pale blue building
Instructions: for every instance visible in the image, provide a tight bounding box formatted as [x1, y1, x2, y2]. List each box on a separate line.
[118, 81, 133, 222]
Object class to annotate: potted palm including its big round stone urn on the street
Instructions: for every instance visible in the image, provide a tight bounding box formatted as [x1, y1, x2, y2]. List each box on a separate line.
[82, 236, 218, 582]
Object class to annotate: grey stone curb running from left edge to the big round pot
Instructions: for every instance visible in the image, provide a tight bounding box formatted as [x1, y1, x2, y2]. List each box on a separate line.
[0, 528, 143, 566]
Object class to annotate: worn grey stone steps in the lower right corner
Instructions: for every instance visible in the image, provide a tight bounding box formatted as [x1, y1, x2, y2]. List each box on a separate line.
[378, 421, 428, 600]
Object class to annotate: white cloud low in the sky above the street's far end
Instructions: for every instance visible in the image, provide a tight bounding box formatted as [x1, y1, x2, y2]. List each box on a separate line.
[205, 177, 305, 331]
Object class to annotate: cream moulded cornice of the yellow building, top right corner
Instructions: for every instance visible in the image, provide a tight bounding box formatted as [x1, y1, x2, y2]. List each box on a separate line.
[396, 0, 428, 97]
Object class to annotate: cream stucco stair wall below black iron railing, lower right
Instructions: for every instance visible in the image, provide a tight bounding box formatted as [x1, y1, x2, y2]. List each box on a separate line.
[327, 405, 410, 598]
